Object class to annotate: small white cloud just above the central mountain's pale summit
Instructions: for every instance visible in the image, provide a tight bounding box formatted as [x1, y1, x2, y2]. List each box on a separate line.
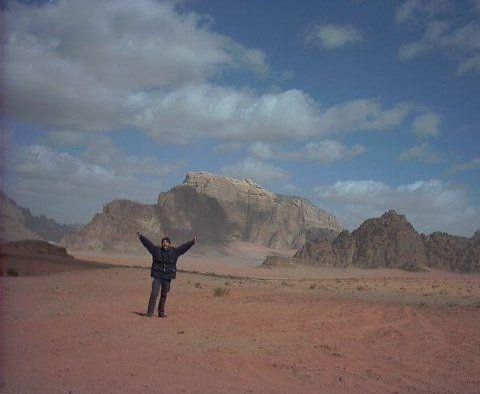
[220, 157, 290, 184]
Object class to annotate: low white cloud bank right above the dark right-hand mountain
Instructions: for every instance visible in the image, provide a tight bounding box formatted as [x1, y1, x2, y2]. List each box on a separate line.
[315, 179, 480, 236]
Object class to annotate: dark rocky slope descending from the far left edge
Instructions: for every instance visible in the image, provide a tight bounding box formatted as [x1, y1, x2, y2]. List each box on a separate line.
[0, 192, 77, 242]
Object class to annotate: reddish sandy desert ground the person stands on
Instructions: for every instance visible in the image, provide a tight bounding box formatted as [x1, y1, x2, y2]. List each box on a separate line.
[0, 244, 480, 394]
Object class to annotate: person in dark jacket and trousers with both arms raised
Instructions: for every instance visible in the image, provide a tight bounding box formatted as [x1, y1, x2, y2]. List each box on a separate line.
[136, 230, 198, 317]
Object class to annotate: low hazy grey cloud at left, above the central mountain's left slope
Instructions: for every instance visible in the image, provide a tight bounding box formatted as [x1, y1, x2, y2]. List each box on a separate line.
[6, 141, 185, 223]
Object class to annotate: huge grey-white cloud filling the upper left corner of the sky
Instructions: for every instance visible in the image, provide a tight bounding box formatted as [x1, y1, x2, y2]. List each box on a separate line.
[4, 0, 267, 131]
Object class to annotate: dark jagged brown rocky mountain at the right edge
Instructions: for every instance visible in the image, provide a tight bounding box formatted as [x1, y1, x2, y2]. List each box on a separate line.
[294, 210, 480, 272]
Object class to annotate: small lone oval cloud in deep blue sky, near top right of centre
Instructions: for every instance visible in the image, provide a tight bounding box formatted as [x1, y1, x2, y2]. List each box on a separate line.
[305, 24, 363, 49]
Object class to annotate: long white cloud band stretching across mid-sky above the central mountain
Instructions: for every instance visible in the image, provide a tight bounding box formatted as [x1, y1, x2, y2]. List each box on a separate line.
[136, 84, 412, 143]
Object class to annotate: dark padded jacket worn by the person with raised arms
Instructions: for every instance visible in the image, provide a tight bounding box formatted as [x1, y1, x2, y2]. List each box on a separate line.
[139, 234, 195, 280]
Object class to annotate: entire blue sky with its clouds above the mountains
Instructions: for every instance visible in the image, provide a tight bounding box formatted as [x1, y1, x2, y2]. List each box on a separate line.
[3, 0, 480, 236]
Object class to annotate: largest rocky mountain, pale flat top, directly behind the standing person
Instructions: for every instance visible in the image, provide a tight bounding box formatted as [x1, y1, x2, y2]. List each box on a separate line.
[64, 172, 342, 252]
